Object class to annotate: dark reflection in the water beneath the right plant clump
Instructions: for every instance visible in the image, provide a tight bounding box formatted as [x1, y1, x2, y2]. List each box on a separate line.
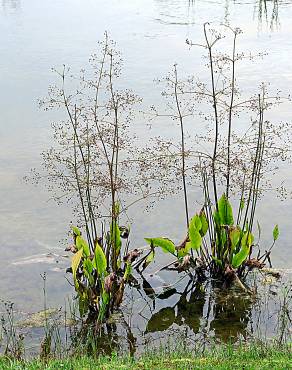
[145, 281, 254, 342]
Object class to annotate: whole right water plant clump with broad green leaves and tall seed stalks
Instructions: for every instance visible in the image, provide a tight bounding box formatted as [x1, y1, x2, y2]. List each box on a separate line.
[145, 24, 289, 289]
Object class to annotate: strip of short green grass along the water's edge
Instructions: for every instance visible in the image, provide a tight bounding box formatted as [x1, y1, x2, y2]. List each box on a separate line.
[0, 345, 292, 370]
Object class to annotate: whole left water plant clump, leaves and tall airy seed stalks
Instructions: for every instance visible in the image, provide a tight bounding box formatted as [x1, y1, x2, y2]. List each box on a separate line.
[34, 34, 150, 323]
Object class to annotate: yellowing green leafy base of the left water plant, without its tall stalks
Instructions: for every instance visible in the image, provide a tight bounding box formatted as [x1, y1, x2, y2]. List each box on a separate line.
[67, 222, 140, 323]
